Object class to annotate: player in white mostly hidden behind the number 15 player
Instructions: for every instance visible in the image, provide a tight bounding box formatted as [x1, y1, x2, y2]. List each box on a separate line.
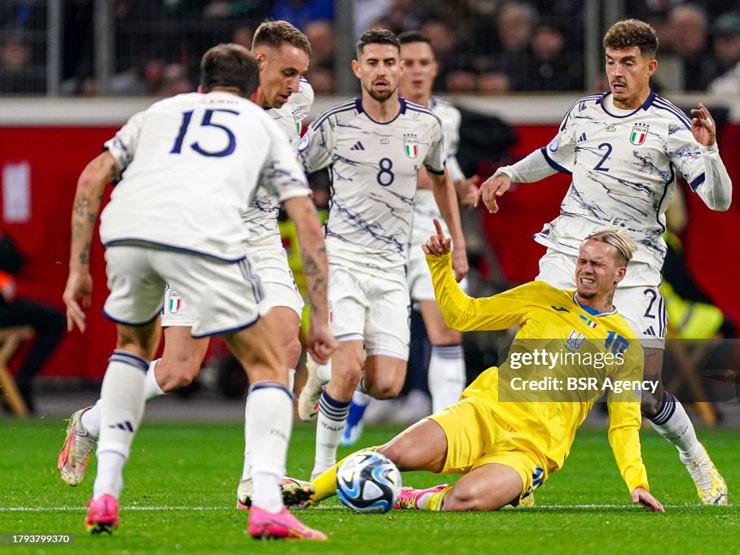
[58, 21, 326, 508]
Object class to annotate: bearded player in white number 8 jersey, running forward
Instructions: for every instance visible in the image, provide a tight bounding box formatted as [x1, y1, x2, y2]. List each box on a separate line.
[298, 29, 468, 482]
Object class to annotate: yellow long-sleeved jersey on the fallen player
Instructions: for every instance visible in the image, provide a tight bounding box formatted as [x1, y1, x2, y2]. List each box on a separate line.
[427, 255, 651, 490]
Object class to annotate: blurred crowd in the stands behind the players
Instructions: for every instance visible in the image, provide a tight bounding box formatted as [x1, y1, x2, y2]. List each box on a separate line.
[0, 0, 740, 97]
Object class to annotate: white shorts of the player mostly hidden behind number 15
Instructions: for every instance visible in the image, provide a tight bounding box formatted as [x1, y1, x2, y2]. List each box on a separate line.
[162, 248, 303, 327]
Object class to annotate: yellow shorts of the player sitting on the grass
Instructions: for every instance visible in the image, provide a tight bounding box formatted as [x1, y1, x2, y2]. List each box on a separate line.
[429, 397, 548, 498]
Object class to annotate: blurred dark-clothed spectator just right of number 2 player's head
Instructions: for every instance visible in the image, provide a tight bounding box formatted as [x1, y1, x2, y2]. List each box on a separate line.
[668, 4, 711, 91]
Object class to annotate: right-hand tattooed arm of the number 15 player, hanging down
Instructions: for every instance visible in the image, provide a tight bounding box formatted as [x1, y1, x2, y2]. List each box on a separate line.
[283, 197, 337, 364]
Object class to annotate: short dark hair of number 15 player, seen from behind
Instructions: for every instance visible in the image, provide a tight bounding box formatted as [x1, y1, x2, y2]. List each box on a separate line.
[200, 44, 259, 98]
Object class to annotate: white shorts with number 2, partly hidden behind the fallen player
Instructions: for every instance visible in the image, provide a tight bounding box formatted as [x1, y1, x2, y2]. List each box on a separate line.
[535, 249, 668, 349]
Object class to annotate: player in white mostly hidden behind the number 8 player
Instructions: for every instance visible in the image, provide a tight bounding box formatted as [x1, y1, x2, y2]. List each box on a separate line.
[342, 31, 478, 445]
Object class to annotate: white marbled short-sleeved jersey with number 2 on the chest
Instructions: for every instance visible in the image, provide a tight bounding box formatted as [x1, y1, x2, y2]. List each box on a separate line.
[535, 93, 705, 271]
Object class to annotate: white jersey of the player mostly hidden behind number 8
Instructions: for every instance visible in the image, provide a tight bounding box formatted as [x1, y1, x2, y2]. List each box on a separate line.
[411, 96, 465, 249]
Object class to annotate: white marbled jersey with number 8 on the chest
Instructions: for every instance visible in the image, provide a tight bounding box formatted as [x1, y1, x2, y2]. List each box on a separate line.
[298, 98, 444, 276]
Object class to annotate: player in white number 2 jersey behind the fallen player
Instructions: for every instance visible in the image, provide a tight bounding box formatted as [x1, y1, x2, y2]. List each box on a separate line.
[479, 19, 732, 505]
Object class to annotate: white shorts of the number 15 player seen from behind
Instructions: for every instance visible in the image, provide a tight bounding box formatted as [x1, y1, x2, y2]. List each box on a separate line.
[103, 246, 262, 337]
